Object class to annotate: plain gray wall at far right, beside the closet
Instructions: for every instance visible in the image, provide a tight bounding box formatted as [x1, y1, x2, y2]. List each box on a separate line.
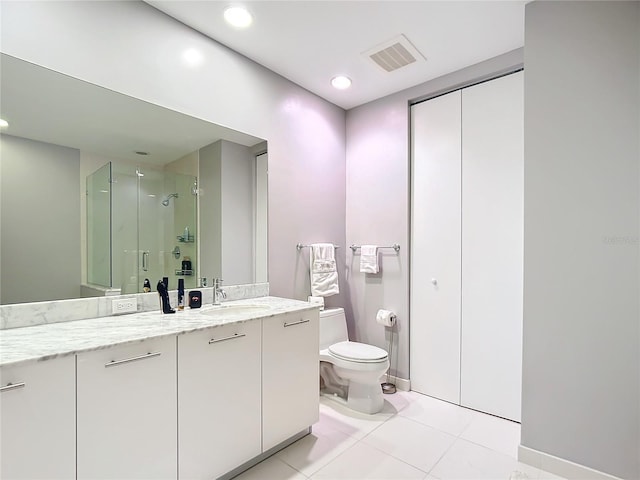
[522, 2, 640, 479]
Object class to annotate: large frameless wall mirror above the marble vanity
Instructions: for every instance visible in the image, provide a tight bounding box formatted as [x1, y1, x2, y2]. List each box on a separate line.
[0, 54, 267, 304]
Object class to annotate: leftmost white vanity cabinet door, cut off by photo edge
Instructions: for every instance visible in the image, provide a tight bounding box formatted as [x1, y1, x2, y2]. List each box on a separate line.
[0, 356, 76, 480]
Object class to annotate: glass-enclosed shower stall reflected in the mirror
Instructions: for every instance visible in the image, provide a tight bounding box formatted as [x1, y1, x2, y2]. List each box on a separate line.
[86, 162, 198, 294]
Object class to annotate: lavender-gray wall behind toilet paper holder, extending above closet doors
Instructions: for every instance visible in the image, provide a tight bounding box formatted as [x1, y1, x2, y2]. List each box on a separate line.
[345, 49, 523, 378]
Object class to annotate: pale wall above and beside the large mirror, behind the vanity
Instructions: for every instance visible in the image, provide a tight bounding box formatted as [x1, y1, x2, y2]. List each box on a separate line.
[0, 1, 345, 305]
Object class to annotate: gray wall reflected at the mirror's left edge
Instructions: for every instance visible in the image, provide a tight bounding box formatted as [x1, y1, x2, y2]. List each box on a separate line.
[0, 135, 80, 304]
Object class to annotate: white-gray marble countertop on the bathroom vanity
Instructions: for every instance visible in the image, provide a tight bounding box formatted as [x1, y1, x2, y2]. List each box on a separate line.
[0, 297, 318, 366]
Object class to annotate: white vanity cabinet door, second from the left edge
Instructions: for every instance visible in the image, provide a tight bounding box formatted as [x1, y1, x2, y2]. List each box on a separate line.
[77, 337, 177, 480]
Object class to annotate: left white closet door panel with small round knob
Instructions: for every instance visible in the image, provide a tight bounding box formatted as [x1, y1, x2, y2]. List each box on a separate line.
[410, 91, 461, 403]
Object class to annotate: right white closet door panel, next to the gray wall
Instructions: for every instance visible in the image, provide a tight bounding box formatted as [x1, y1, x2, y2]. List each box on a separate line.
[460, 72, 524, 421]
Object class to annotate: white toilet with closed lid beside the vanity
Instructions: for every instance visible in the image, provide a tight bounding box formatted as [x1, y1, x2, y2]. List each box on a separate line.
[320, 308, 389, 414]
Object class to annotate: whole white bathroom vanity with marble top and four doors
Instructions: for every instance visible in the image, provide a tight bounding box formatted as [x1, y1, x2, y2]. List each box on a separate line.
[0, 297, 319, 480]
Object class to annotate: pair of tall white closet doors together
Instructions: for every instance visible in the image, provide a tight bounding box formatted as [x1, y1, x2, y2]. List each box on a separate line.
[410, 71, 524, 421]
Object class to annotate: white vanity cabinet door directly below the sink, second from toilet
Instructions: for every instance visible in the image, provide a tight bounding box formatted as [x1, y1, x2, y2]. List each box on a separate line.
[178, 320, 262, 479]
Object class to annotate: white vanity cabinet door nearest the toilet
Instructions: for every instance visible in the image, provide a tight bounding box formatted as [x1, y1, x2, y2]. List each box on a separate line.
[262, 310, 320, 451]
